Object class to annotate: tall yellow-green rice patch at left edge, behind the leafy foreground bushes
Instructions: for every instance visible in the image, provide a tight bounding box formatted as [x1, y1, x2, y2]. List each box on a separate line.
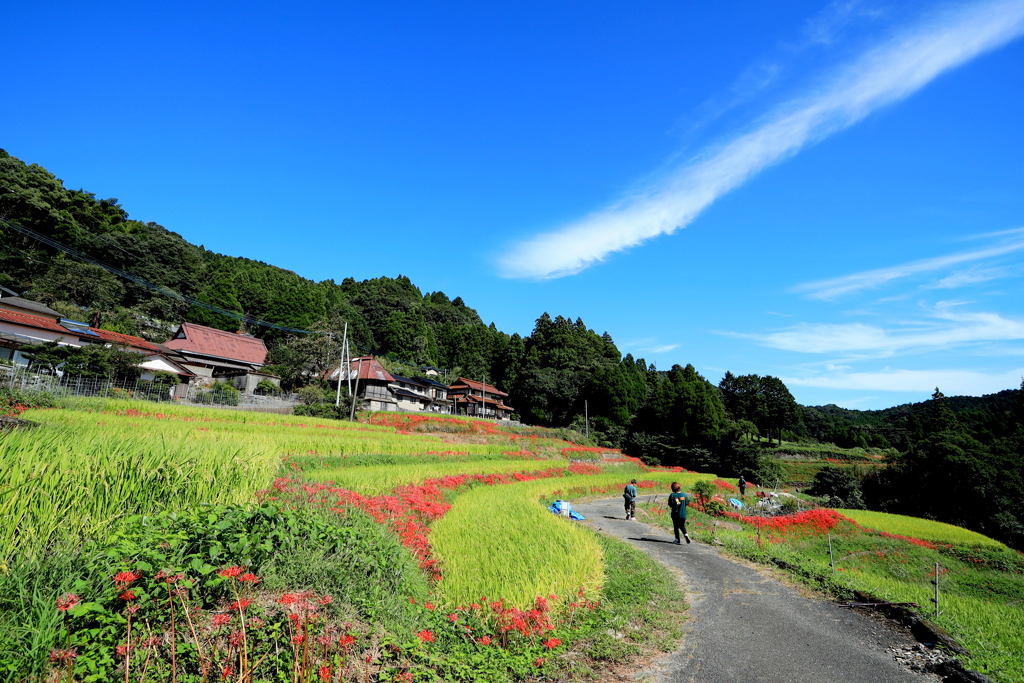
[0, 425, 278, 563]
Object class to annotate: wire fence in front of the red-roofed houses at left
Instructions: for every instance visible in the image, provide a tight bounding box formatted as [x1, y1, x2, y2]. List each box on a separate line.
[0, 364, 302, 412]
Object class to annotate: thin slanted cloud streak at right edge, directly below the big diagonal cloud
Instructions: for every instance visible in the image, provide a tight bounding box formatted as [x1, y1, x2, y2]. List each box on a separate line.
[793, 230, 1024, 300]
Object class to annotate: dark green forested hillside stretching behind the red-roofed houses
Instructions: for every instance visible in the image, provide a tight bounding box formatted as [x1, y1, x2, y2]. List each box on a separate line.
[0, 150, 1024, 547]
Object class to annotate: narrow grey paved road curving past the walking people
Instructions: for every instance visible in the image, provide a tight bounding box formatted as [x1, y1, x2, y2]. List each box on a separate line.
[574, 499, 941, 683]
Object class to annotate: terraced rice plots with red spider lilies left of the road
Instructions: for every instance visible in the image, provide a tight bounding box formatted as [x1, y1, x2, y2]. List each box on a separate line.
[0, 395, 685, 683]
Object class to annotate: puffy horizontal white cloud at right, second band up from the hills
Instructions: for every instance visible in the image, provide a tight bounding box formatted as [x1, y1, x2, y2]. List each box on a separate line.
[743, 302, 1024, 355]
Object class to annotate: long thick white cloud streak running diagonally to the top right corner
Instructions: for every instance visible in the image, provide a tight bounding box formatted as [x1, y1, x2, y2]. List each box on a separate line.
[500, 0, 1024, 279]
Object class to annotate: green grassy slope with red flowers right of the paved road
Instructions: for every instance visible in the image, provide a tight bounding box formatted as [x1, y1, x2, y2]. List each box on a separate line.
[638, 480, 1024, 683]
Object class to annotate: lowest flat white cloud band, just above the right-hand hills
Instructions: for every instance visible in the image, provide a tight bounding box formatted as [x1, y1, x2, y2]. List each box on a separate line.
[781, 368, 1024, 396]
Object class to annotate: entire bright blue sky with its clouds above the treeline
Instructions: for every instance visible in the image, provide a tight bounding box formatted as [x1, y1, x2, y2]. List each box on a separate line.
[6, 0, 1024, 408]
